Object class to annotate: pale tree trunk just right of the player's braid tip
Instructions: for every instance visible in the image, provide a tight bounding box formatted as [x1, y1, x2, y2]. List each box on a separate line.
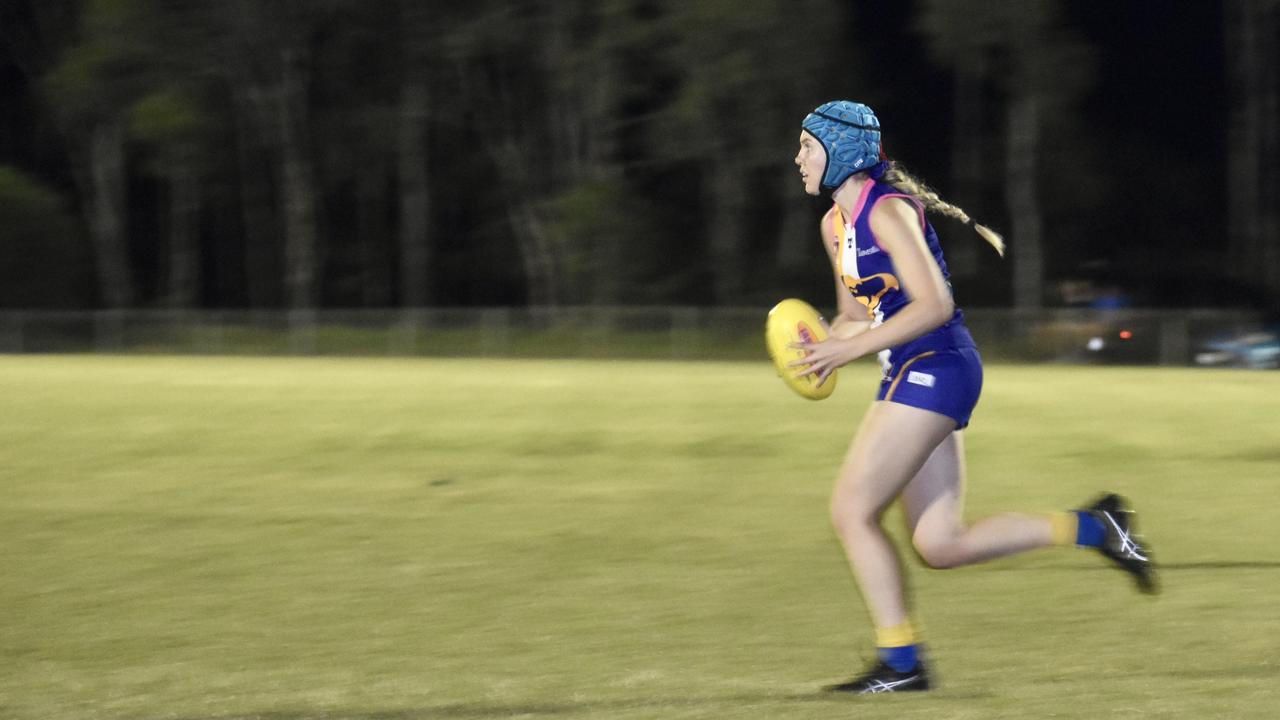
[1005, 88, 1044, 310]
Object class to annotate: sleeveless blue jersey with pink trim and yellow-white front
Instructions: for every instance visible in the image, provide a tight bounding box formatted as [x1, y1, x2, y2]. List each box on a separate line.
[828, 179, 975, 374]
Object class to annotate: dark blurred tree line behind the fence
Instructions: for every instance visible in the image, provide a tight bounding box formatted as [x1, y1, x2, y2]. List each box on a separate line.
[0, 0, 1280, 307]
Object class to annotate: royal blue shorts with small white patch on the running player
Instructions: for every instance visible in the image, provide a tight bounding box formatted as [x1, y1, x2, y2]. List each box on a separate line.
[876, 347, 982, 430]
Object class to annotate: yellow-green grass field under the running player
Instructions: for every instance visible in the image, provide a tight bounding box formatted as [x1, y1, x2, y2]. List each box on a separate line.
[0, 356, 1280, 720]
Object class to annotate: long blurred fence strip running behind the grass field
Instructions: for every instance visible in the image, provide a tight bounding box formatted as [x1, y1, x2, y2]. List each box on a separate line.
[0, 306, 1262, 365]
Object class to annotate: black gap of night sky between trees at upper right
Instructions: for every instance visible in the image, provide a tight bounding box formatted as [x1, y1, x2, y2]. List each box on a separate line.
[1071, 1, 1228, 280]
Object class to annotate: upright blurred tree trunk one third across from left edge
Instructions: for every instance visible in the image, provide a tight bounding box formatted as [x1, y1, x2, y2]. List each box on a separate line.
[397, 78, 433, 307]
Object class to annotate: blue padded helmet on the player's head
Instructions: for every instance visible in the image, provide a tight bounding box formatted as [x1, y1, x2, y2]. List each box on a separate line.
[800, 100, 881, 190]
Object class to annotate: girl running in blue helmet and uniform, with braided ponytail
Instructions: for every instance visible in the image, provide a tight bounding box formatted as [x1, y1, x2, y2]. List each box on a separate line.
[792, 100, 1156, 693]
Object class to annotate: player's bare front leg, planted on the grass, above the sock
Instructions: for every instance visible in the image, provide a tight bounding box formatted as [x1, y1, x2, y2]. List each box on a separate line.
[831, 402, 955, 628]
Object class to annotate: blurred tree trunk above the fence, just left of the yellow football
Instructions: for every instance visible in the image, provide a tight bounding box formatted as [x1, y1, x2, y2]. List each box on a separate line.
[708, 158, 748, 305]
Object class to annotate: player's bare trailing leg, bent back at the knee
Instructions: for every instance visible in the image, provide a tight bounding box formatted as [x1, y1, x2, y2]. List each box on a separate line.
[902, 432, 1052, 568]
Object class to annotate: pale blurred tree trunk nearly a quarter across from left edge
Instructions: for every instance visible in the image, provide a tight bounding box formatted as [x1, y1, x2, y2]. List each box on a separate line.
[276, 47, 320, 310]
